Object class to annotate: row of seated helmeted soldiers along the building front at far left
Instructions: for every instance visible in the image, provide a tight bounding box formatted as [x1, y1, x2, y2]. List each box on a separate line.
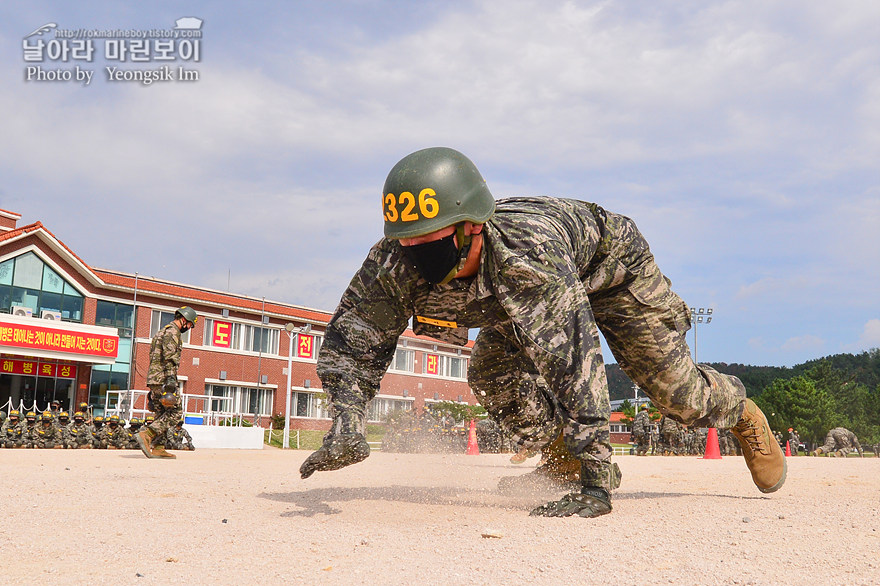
[0, 410, 195, 450]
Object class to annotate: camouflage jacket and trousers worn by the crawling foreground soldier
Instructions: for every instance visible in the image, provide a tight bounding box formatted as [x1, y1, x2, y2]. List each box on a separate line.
[317, 198, 745, 490]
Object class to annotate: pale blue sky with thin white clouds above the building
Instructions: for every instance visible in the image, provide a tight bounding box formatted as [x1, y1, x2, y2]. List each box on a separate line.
[0, 0, 880, 366]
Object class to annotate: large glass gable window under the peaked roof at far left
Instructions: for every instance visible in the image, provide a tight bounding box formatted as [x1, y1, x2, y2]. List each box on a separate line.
[0, 252, 83, 322]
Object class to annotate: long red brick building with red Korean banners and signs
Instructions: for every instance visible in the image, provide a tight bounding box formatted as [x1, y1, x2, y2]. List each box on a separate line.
[0, 210, 476, 429]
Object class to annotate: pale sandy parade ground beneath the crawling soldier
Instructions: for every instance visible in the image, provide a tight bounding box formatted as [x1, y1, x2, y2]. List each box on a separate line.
[0, 448, 880, 585]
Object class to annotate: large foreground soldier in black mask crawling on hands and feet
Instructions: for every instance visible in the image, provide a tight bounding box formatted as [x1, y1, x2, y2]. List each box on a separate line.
[300, 148, 786, 517]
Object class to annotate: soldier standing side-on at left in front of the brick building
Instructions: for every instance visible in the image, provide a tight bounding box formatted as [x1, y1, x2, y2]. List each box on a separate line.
[137, 307, 199, 458]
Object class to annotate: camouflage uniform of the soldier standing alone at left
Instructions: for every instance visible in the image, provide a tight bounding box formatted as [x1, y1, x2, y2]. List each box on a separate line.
[147, 322, 183, 443]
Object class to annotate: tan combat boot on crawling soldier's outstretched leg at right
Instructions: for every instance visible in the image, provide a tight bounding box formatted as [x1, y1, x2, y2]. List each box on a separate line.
[730, 399, 788, 492]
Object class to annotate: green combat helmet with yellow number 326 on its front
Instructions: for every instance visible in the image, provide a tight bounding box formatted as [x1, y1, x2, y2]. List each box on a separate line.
[382, 147, 495, 240]
